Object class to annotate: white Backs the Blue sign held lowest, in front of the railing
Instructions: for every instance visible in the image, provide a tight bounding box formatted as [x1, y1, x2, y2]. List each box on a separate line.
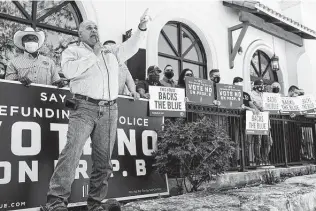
[246, 111, 269, 135]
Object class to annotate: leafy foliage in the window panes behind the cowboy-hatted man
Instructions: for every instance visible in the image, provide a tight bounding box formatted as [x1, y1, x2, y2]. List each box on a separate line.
[0, 1, 79, 70]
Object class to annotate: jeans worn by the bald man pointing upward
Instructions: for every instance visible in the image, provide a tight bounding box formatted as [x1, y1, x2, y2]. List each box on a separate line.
[46, 100, 118, 211]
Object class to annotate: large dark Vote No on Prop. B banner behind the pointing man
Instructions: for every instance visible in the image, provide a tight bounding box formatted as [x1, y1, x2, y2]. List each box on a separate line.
[0, 81, 169, 210]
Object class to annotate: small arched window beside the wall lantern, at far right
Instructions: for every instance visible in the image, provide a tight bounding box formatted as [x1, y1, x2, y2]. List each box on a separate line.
[250, 50, 278, 91]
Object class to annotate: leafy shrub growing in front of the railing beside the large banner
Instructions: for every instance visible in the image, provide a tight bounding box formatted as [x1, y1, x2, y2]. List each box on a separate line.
[153, 116, 235, 192]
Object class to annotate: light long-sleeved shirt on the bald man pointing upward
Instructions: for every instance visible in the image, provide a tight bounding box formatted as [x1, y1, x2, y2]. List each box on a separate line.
[61, 29, 145, 100]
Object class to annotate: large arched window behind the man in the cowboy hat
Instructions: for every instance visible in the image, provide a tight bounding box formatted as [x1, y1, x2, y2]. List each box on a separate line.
[0, 0, 82, 74]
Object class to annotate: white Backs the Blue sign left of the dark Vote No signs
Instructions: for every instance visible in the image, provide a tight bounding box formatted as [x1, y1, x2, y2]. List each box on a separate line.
[149, 86, 186, 117]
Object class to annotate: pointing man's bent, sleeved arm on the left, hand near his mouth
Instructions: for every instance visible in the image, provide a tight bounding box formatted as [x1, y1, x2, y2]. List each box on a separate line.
[61, 47, 97, 79]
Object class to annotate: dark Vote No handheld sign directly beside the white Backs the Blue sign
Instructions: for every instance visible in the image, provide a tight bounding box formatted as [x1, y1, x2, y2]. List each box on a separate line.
[185, 77, 214, 105]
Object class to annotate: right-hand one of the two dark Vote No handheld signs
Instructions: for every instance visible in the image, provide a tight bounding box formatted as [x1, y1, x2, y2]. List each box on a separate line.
[216, 84, 243, 109]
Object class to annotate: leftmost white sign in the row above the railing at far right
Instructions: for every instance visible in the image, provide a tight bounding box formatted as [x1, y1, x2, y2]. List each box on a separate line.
[262, 92, 281, 114]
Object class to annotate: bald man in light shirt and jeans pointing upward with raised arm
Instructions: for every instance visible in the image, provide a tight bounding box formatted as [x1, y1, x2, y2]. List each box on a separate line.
[43, 10, 150, 211]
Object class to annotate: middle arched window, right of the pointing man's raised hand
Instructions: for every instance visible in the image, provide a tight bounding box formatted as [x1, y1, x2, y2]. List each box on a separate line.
[158, 22, 207, 81]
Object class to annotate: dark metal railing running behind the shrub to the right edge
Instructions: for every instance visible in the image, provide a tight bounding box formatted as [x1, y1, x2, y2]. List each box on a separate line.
[187, 103, 316, 171]
